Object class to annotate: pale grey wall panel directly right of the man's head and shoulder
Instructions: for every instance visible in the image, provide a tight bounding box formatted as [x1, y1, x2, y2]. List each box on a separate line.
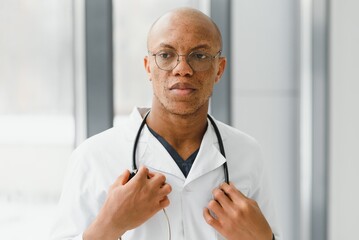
[231, 0, 299, 240]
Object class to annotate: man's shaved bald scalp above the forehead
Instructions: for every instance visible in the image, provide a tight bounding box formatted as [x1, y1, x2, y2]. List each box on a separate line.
[147, 8, 222, 49]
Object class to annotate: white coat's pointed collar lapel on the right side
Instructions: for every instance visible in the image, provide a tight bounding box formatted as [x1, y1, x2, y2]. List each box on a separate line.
[185, 123, 226, 185]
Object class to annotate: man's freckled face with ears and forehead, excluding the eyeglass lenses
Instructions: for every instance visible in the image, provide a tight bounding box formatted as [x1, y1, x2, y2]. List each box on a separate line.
[144, 11, 226, 115]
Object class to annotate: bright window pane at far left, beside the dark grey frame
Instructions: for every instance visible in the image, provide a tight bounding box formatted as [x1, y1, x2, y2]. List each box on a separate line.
[0, 0, 75, 239]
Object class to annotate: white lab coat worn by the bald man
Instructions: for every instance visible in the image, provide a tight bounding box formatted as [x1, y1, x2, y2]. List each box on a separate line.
[50, 109, 280, 240]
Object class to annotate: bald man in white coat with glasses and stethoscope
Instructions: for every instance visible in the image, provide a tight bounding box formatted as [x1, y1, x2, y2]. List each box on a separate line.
[51, 8, 280, 240]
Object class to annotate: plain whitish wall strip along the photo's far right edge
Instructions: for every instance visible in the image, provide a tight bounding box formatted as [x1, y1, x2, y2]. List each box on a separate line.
[329, 0, 359, 240]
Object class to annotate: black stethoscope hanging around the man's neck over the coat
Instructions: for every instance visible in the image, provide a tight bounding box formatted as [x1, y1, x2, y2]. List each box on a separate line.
[129, 111, 229, 240]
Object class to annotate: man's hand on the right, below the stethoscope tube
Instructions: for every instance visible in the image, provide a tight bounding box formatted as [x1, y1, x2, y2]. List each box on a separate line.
[203, 183, 272, 240]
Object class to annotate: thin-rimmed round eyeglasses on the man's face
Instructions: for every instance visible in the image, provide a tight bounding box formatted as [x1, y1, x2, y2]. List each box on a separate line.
[148, 49, 221, 72]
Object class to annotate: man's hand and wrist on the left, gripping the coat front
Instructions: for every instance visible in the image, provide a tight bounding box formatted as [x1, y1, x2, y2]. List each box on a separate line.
[83, 166, 172, 240]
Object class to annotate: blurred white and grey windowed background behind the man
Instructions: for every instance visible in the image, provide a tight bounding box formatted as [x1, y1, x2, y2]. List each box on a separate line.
[0, 0, 359, 240]
